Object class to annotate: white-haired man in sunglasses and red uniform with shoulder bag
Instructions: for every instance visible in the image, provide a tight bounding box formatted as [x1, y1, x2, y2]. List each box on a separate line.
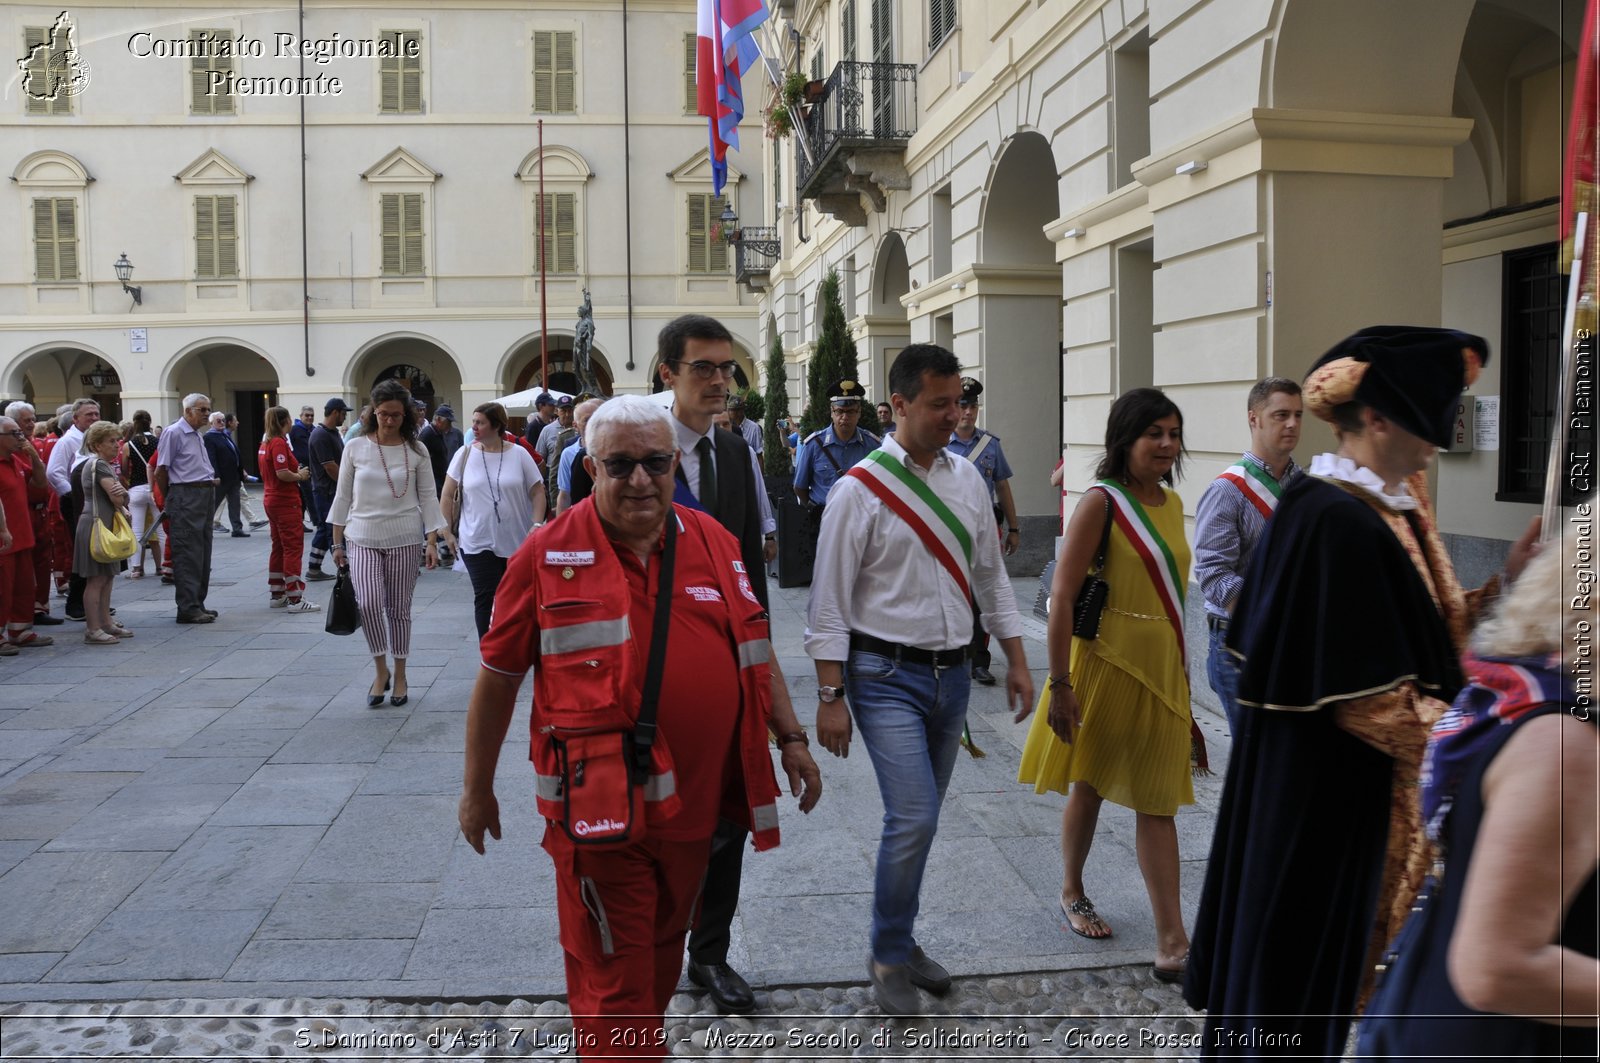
[459, 395, 822, 1060]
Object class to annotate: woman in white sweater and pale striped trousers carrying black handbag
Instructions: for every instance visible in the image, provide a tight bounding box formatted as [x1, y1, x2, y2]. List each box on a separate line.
[328, 379, 454, 708]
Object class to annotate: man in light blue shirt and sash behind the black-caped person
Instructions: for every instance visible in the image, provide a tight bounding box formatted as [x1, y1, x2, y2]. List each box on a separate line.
[1195, 376, 1302, 733]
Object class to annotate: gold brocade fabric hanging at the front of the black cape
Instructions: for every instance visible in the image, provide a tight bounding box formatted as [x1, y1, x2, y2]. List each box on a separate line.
[1334, 682, 1446, 1010]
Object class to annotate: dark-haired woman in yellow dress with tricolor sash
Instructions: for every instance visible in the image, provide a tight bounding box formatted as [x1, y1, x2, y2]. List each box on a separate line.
[1019, 387, 1194, 981]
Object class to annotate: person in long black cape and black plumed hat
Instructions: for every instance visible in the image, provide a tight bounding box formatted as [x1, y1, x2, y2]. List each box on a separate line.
[1184, 325, 1536, 1060]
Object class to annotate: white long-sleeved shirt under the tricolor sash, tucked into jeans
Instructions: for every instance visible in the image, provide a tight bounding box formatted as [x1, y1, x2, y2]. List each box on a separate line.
[805, 435, 1022, 661]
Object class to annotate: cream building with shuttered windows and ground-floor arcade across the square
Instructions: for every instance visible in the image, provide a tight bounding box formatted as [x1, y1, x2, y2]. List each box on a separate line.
[0, 0, 762, 470]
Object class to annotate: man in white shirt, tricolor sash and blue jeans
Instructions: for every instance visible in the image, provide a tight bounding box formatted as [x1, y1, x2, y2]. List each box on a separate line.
[805, 344, 1034, 1015]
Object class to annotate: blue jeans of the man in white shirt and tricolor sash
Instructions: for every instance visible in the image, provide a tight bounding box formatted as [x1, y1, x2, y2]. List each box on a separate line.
[845, 652, 973, 964]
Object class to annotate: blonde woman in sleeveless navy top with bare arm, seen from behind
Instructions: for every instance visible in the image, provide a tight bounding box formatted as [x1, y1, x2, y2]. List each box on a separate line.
[1357, 523, 1600, 1060]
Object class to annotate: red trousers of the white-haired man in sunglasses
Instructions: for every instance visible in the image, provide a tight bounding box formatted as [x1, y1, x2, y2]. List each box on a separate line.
[544, 823, 710, 1060]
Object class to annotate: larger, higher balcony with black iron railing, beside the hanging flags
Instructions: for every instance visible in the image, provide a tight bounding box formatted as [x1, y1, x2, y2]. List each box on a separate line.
[795, 62, 917, 226]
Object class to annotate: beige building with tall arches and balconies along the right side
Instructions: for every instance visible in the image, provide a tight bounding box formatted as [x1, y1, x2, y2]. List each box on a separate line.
[741, 0, 1582, 581]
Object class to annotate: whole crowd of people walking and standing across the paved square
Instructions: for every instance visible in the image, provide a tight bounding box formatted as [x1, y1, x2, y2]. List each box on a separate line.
[0, 314, 1600, 1058]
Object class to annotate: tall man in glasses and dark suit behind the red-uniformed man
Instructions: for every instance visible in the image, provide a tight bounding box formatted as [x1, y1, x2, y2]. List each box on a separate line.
[656, 314, 793, 1012]
